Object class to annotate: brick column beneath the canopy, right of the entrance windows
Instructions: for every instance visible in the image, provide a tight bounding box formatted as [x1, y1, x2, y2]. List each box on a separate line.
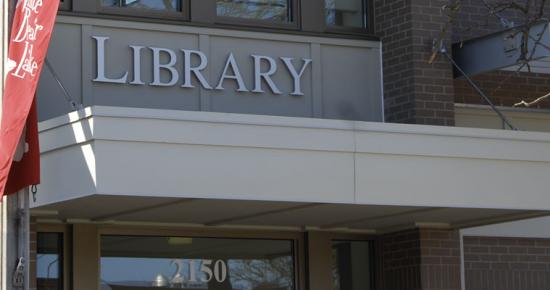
[377, 229, 461, 290]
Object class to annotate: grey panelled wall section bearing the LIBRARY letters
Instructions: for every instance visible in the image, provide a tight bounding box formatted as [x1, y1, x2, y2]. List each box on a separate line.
[38, 22, 384, 122]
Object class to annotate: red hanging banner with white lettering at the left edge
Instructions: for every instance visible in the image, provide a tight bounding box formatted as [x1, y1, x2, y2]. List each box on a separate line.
[0, 0, 59, 195]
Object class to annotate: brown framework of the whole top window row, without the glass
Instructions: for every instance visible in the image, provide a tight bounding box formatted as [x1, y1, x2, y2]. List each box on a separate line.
[64, 0, 379, 41]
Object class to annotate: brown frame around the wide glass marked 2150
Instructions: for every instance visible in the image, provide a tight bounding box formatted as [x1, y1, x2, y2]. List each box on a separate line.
[97, 226, 306, 290]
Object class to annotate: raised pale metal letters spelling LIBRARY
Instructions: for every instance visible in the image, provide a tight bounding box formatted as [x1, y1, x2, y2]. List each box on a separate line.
[92, 36, 312, 96]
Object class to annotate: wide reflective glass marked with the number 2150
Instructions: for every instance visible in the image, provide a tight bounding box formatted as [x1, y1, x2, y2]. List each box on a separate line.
[101, 236, 295, 290]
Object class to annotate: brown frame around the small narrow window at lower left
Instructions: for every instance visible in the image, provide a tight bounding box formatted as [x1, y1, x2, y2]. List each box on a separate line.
[32, 224, 71, 290]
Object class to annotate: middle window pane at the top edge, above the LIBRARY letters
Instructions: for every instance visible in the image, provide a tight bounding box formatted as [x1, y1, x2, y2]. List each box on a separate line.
[216, 0, 292, 23]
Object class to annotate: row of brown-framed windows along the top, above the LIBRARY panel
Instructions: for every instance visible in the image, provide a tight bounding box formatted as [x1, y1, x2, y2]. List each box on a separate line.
[60, 0, 378, 38]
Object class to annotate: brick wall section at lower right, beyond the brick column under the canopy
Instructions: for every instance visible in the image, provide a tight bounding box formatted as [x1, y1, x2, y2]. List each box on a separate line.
[464, 237, 550, 290]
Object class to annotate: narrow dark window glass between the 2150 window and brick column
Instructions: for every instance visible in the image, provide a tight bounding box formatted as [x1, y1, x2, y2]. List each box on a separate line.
[332, 241, 374, 290]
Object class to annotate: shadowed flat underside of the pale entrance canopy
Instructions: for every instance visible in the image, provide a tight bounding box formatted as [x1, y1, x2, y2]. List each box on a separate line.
[33, 195, 550, 234]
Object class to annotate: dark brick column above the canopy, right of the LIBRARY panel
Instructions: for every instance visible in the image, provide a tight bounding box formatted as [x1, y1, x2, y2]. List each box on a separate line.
[374, 0, 454, 126]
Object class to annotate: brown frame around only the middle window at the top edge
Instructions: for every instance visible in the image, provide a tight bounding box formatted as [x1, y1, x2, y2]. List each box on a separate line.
[216, 0, 302, 30]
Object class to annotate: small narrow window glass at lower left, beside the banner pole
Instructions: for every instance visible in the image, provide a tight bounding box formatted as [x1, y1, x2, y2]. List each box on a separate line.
[36, 233, 63, 290]
